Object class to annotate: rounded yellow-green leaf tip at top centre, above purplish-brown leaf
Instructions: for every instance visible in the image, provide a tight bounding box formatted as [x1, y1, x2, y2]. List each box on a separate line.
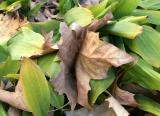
[64, 7, 93, 27]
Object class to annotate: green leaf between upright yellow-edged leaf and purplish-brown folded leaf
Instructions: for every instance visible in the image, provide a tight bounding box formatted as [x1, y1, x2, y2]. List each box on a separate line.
[38, 54, 60, 77]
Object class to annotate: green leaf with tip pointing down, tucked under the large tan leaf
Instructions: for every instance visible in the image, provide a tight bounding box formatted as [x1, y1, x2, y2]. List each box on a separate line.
[90, 69, 115, 104]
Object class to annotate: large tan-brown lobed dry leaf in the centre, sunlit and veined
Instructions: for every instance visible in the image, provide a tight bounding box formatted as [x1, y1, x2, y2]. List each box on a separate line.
[76, 32, 134, 109]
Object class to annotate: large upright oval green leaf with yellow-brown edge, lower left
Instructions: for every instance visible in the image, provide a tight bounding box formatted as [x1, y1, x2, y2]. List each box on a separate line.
[20, 58, 50, 116]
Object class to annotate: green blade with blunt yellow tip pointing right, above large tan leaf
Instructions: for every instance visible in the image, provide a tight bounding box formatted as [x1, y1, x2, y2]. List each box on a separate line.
[103, 21, 143, 39]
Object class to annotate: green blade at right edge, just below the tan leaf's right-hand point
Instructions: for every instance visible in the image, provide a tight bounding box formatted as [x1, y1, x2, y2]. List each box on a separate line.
[122, 59, 160, 90]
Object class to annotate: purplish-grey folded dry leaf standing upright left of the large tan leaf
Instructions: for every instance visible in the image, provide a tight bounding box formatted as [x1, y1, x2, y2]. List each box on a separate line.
[51, 23, 85, 109]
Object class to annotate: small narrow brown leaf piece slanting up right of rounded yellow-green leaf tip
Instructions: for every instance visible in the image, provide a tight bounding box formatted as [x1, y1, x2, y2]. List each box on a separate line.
[88, 12, 113, 31]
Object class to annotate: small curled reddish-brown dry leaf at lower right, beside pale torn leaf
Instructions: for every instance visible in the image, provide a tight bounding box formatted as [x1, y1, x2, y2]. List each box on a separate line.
[113, 85, 138, 107]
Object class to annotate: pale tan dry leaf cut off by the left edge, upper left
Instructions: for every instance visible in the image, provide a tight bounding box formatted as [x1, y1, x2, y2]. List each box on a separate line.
[0, 14, 25, 40]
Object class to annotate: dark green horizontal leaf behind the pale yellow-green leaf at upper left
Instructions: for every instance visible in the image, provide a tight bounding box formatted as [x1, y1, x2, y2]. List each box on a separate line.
[24, 20, 60, 34]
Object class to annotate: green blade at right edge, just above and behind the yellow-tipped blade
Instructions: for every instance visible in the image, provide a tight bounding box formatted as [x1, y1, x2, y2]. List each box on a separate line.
[132, 9, 160, 25]
